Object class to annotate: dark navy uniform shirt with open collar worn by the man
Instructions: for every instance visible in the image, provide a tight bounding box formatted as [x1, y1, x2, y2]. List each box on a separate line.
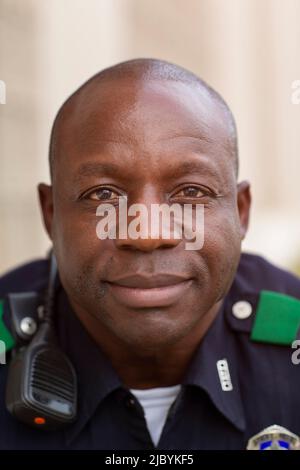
[0, 254, 300, 450]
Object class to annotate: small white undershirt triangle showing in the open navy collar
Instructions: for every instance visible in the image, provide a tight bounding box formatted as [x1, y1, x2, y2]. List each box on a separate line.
[130, 385, 180, 446]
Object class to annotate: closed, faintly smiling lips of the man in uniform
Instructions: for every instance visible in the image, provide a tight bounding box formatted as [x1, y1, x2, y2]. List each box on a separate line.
[106, 274, 193, 308]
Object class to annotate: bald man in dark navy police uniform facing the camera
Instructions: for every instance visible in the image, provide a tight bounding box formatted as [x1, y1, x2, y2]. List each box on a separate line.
[0, 59, 300, 450]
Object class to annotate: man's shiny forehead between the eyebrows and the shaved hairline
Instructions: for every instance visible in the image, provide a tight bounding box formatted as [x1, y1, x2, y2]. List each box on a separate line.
[56, 79, 232, 178]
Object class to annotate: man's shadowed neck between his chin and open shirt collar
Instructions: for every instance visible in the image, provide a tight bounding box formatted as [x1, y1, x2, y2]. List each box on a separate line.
[71, 301, 222, 389]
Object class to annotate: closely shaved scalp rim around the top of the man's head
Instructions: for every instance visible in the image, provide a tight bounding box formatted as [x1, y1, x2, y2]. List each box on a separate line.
[49, 59, 238, 177]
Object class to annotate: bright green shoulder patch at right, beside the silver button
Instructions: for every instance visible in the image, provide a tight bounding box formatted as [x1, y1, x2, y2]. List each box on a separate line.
[250, 290, 300, 345]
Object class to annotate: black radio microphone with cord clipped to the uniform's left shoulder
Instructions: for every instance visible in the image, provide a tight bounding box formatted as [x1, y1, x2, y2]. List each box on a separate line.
[6, 253, 77, 430]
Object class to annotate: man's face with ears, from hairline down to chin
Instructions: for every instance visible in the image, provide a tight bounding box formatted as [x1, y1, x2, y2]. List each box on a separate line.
[40, 79, 250, 348]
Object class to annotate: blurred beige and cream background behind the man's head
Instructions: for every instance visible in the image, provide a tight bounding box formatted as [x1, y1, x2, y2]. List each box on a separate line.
[0, 0, 300, 273]
